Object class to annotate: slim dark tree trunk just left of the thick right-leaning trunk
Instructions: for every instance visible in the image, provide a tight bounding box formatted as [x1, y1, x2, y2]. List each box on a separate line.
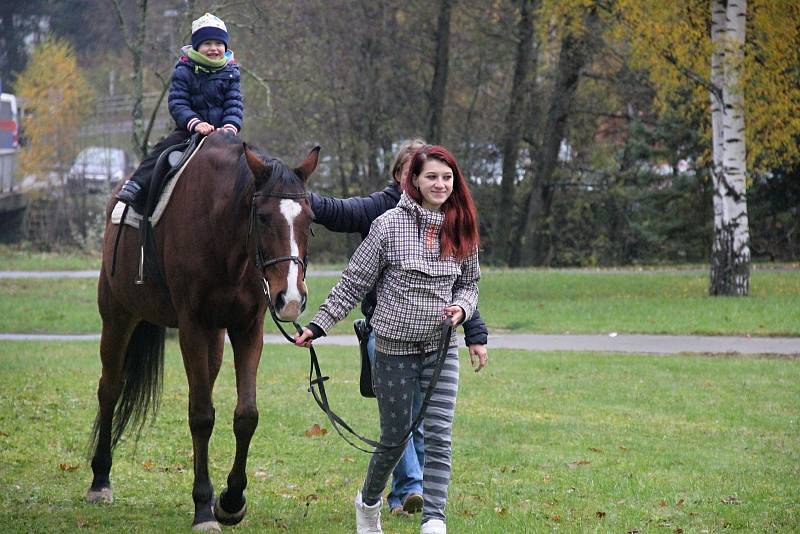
[494, 0, 536, 264]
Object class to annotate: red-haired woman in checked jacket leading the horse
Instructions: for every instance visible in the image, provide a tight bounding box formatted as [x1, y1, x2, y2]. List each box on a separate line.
[295, 145, 478, 534]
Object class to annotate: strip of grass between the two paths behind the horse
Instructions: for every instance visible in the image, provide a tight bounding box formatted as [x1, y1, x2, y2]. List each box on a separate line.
[0, 270, 800, 336]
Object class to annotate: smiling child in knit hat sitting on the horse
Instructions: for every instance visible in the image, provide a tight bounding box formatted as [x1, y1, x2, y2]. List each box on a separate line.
[116, 13, 244, 208]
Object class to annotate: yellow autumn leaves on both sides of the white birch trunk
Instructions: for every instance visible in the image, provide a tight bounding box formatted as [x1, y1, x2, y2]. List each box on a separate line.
[607, 0, 800, 172]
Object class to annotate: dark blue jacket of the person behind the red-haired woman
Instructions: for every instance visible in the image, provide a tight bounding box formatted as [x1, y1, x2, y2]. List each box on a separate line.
[309, 180, 489, 345]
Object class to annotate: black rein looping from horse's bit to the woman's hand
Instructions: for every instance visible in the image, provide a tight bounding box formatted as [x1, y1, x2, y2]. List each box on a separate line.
[261, 277, 453, 454]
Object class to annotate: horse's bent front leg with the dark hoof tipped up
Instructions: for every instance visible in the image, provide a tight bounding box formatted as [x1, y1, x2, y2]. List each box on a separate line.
[214, 321, 264, 525]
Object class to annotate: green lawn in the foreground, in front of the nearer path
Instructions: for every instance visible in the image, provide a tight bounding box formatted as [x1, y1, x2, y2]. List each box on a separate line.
[0, 341, 800, 534]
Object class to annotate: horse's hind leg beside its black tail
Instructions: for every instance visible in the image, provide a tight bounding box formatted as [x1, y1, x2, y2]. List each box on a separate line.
[86, 284, 136, 503]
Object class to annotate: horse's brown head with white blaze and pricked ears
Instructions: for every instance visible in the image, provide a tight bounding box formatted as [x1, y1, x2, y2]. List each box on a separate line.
[244, 146, 320, 321]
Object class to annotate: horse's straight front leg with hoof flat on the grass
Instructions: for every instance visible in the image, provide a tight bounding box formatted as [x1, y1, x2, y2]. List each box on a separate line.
[179, 320, 221, 532]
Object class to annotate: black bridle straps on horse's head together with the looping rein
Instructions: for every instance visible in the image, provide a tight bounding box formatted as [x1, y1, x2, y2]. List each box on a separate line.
[247, 191, 453, 454]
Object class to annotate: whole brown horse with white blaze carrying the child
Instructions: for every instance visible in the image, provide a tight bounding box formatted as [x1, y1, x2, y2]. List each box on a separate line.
[86, 132, 319, 531]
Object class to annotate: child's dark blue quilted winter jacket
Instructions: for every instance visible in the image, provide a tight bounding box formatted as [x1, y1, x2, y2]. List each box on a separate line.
[168, 50, 244, 131]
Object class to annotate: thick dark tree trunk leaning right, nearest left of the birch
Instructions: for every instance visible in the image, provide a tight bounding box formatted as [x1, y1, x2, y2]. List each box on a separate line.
[508, 8, 597, 267]
